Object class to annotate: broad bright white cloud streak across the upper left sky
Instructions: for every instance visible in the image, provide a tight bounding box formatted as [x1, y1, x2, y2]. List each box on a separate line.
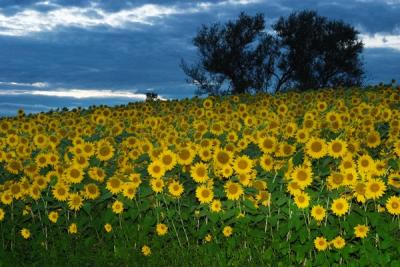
[0, 0, 259, 36]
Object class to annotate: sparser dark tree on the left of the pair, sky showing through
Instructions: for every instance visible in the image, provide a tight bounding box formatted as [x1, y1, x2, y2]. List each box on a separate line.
[181, 13, 277, 95]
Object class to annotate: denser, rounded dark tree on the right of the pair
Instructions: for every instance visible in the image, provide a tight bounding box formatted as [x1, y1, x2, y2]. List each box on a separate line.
[272, 11, 363, 91]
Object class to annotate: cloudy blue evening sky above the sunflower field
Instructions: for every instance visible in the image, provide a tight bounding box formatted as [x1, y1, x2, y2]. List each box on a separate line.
[0, 0, 400, 116]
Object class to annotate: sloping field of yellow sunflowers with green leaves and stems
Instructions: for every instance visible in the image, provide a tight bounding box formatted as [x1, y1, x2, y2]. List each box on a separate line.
[0, 86, 400, 266]
